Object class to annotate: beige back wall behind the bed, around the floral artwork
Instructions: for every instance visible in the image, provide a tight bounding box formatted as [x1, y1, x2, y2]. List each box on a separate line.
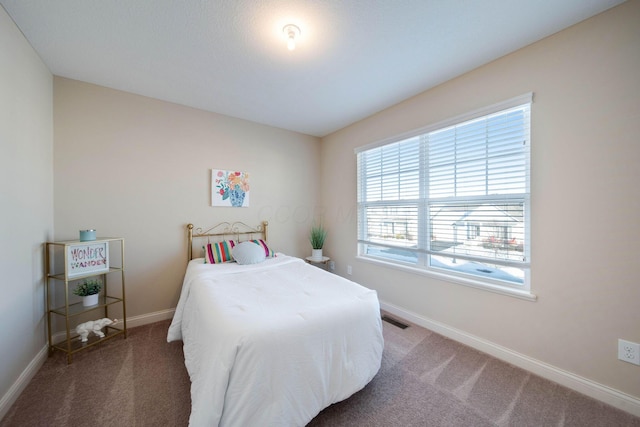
[54, 77, 320, 317]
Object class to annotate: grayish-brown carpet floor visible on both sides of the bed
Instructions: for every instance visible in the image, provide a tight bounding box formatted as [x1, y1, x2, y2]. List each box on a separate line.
[0, 321, 640, 427]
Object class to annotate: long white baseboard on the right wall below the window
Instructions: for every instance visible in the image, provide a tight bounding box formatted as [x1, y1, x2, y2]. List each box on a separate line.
[380, 301, 640, 417]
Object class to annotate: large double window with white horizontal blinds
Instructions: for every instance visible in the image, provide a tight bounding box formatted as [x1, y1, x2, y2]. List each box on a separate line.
[356, 94, 532, 292]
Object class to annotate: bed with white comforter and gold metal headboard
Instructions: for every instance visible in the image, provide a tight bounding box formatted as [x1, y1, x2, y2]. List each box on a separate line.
[167, 222, 384, 426]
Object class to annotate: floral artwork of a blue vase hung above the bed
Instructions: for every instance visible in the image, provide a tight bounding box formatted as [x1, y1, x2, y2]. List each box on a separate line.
[211, 169, 251, 208]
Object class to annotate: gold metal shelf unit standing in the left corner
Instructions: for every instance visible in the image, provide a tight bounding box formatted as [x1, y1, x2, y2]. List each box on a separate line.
[44, 237, 127, 363]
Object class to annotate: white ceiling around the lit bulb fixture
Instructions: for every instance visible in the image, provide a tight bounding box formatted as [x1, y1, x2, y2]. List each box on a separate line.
[0, 0, 622, 136]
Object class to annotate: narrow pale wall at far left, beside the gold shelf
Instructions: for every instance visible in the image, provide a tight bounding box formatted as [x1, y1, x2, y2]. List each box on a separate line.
[0, 6, 53, 418]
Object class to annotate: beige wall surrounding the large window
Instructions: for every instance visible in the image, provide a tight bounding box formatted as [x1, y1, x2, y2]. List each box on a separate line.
[321, 0, 640, 398]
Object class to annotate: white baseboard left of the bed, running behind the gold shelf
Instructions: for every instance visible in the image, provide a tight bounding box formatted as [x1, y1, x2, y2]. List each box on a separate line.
[0, 308, 176, 420]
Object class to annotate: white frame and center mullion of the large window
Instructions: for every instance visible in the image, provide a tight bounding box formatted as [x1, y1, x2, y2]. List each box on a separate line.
[354, 92, 536, 300]
